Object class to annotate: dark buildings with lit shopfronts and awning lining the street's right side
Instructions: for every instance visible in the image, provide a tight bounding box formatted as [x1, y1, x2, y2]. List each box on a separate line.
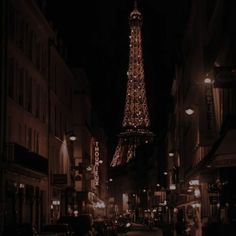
[166, 0, 236, 232]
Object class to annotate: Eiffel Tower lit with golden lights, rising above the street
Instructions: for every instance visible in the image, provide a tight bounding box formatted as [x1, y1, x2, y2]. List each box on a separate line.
[111, 2, 154, 167]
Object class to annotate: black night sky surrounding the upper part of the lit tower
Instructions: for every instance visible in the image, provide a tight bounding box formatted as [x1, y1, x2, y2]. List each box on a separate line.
[47, 0, 189, 148]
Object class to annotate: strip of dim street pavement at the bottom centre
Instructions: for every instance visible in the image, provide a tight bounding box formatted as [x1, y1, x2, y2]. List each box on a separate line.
[118, 224, 163, 236]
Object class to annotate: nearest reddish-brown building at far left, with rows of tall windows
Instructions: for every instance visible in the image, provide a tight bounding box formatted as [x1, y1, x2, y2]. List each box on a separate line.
[1, 1, 53, 229]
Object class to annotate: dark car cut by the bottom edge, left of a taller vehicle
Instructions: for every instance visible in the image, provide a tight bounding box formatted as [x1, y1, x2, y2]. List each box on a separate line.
[39, 224, 72, 236]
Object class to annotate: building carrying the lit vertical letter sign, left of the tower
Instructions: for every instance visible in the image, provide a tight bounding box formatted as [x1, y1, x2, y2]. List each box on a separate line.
[73, 68, 108, 217]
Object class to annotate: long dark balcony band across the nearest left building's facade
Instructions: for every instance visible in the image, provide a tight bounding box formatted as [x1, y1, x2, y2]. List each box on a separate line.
[5, 143, 48, 175]
